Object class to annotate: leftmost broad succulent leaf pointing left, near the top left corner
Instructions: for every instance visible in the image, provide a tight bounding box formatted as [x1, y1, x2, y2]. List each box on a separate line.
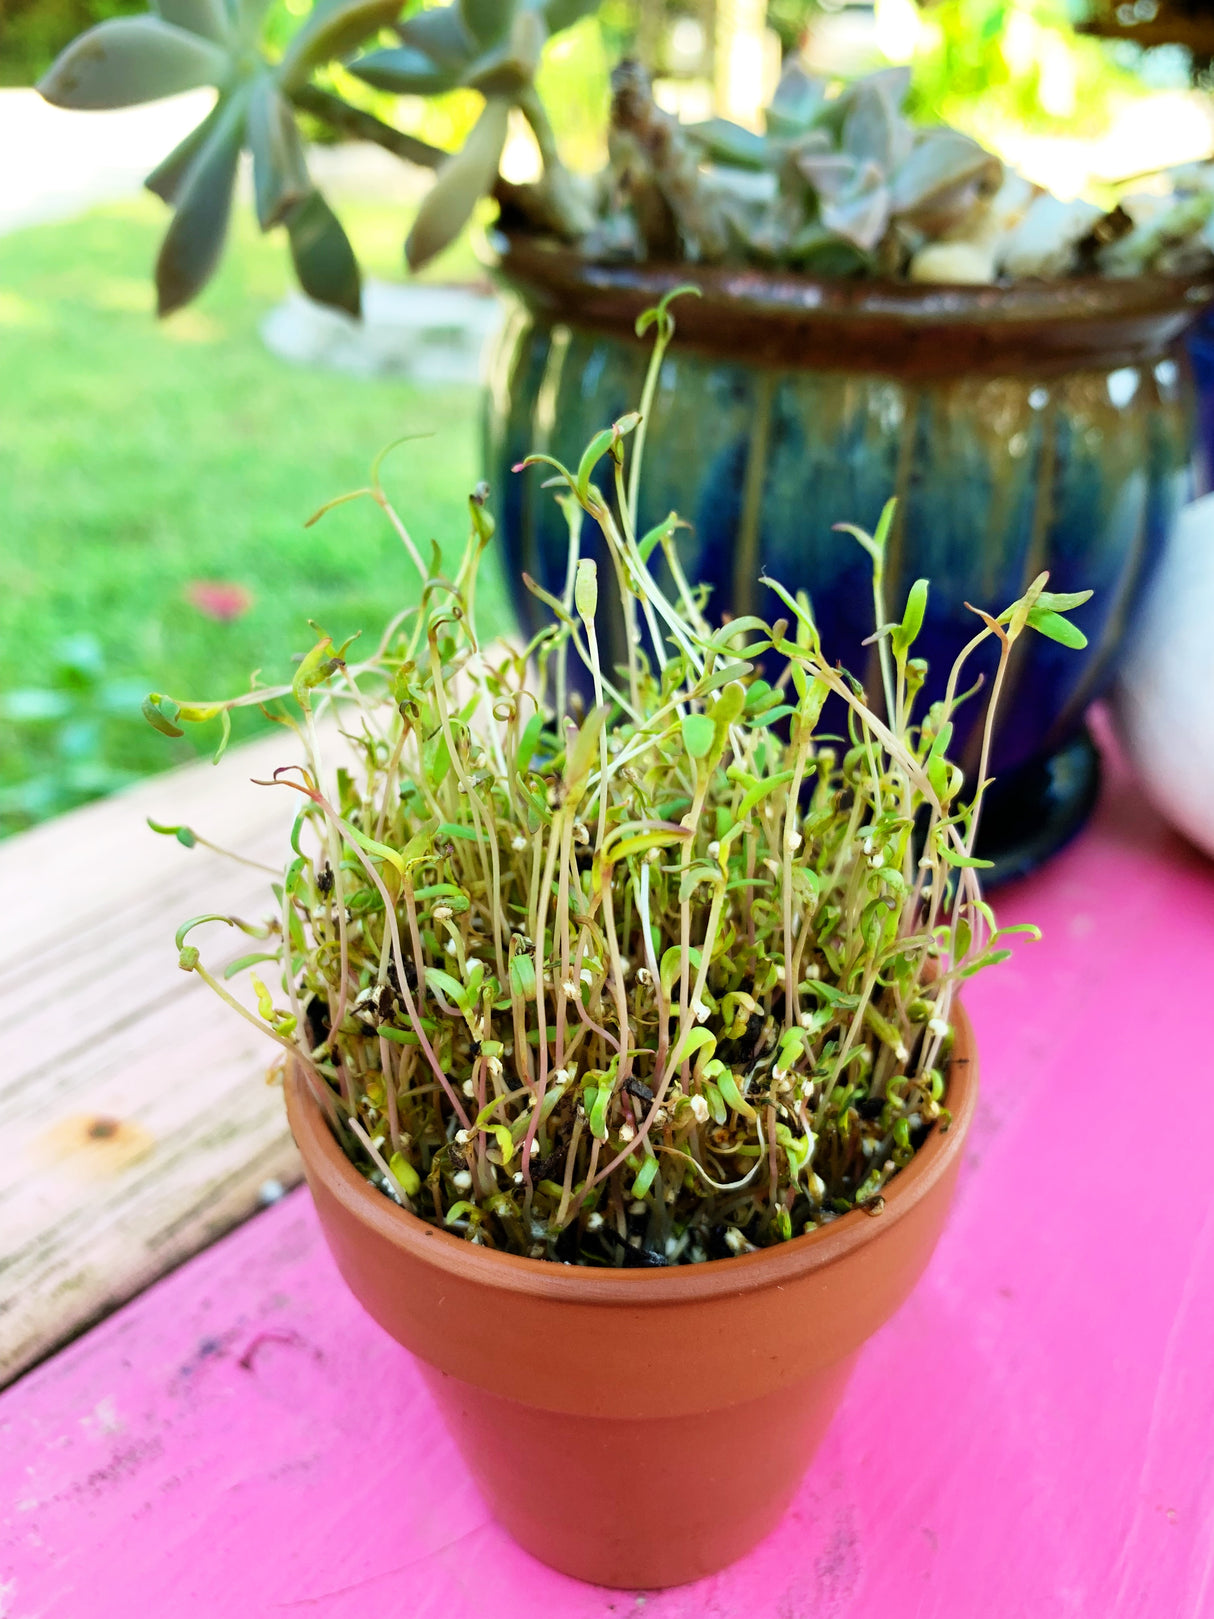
[39, 16, 230, 112]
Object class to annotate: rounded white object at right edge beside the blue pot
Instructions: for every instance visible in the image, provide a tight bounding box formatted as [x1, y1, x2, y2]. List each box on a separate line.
[1115, 495, 1214, 855]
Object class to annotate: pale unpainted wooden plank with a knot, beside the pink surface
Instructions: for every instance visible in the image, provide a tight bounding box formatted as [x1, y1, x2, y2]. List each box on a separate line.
[0, 732, 309, 1383]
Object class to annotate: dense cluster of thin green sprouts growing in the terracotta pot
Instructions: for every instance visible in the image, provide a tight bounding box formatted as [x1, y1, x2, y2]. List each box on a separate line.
[146, 294, 1085, 1266]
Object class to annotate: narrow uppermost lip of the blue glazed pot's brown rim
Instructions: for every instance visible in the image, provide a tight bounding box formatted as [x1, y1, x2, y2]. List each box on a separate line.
[489, 230, 1214, 327]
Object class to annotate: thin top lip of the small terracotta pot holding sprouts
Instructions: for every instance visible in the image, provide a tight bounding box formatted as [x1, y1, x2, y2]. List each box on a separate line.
[285, 1004, 978, 1307]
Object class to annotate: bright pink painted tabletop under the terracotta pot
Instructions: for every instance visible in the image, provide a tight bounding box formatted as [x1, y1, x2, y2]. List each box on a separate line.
[0, 738, 1214, 1619]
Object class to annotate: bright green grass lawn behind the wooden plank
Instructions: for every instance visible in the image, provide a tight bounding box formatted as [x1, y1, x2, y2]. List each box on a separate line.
[0, 198, 500, 831]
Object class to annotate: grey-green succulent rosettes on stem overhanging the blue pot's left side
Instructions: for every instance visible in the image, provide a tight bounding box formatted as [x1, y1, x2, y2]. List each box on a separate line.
[39, 0, 592, 314]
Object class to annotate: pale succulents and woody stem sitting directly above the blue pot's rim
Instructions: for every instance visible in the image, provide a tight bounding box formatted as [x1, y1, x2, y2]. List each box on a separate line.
[605, 62, 1214, 283]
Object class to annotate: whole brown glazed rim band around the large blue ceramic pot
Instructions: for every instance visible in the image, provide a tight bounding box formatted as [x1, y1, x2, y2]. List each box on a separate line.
[494, 232, 1214, 373]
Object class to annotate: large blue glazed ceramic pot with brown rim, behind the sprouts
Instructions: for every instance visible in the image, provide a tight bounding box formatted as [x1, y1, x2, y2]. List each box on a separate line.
[487, 238, 1211, 874]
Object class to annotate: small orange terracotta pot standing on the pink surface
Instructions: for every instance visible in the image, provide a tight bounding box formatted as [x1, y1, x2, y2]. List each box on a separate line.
[287, 1010, 978, 1588]
